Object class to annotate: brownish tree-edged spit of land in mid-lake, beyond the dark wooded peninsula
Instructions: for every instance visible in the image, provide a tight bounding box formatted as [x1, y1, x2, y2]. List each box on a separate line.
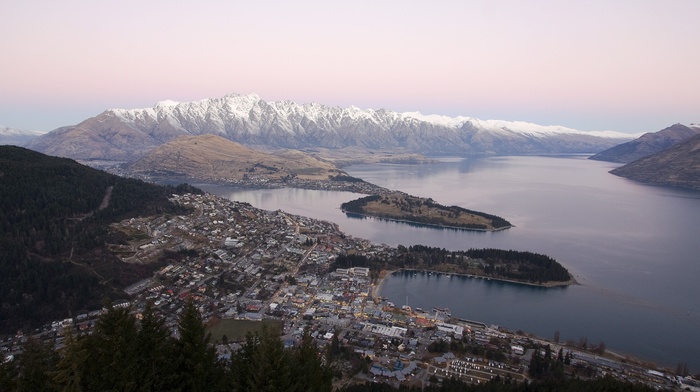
[340, 191, 513, 231]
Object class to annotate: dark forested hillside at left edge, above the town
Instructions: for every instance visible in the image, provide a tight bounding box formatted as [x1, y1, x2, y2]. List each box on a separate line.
[0, 146, 198, 332]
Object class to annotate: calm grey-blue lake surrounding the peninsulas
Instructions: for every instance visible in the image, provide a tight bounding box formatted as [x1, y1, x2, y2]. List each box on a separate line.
[202, 156, 700, 372]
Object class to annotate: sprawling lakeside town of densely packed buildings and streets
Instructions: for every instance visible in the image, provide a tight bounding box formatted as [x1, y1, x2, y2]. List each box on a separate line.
[1, 194, 700, 390]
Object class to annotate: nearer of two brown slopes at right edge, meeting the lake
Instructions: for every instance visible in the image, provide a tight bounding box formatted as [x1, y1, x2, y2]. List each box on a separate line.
[610, 135, 700, 189]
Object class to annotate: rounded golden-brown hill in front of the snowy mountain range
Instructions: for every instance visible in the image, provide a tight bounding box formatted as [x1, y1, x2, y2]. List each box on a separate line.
[125, 135, 345, 181]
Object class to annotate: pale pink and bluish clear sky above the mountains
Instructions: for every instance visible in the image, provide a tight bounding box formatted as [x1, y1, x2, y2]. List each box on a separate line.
[0, 0, 700, 133]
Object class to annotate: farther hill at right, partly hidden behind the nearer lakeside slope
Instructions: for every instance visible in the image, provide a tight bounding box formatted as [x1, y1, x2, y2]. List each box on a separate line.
[589, 124, 700, 163]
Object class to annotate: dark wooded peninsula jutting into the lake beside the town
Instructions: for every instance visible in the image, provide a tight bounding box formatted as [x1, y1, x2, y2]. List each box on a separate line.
[331, 245, 571, 284]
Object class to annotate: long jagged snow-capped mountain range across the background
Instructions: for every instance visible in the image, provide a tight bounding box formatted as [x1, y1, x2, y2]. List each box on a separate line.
[27, 94, 632, 163]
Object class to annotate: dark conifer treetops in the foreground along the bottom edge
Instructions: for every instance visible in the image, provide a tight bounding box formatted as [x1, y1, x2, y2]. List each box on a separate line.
[0, 302, 652, 392]
